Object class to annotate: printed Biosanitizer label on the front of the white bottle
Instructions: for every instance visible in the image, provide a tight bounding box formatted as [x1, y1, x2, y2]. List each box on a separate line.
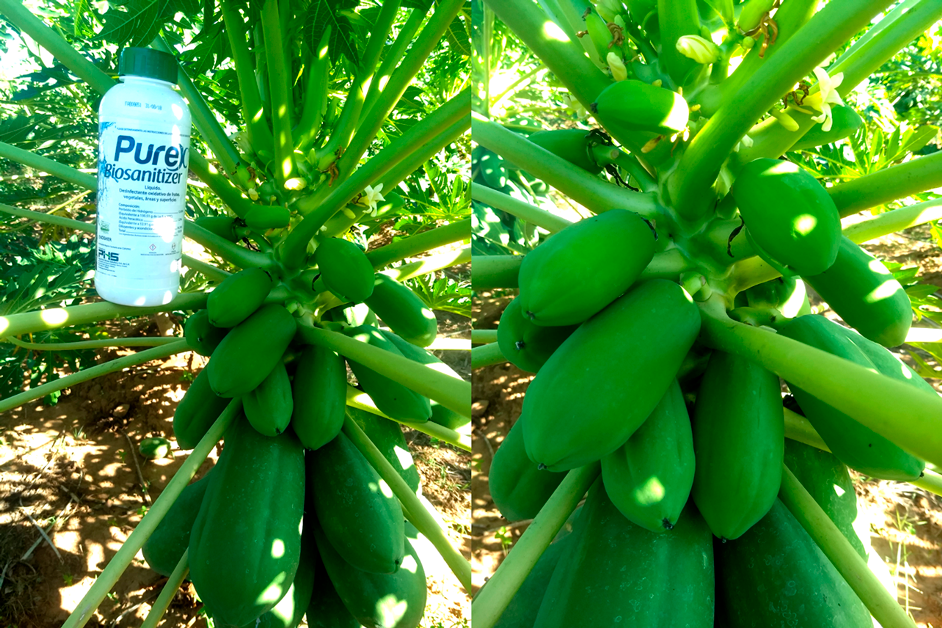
[96, 118, 190, 288]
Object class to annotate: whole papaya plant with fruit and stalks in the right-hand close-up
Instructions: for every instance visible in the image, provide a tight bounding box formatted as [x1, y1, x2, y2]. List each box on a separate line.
[471, 0, 942, 628]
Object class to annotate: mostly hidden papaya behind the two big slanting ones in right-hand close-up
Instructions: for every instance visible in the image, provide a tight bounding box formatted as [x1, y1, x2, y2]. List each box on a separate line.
[497, 297, 576, 373]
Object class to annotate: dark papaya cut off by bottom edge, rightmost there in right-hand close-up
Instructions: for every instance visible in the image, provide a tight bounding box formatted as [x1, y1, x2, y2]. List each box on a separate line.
[714, 499, 873, 628]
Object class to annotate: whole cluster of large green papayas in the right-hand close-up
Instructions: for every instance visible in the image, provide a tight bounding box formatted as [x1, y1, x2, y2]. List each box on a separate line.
[489, 138, 933, 628]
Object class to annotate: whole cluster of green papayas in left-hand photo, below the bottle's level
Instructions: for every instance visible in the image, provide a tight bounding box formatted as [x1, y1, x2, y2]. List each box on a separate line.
[143, 234, 459, 628]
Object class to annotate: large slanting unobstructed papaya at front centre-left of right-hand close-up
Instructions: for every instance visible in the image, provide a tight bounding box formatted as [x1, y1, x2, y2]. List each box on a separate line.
[523, 279, 700, 471]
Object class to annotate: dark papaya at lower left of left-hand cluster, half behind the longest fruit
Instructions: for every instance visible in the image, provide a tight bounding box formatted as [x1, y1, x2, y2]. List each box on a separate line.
[141, 469, 212, 578]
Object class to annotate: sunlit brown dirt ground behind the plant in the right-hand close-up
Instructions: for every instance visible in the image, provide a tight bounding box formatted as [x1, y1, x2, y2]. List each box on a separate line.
[471, 226, 942, 628]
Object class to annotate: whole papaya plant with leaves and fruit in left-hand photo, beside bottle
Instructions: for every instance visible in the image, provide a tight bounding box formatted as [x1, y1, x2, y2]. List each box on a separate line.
[0, 0, 470, 628]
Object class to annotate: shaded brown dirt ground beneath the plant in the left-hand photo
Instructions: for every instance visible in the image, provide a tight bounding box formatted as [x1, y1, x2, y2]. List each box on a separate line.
[0, 267, 471, 628]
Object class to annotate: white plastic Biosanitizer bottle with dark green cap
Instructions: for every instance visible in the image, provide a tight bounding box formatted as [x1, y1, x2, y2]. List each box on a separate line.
[95, 48, 190, 307]
